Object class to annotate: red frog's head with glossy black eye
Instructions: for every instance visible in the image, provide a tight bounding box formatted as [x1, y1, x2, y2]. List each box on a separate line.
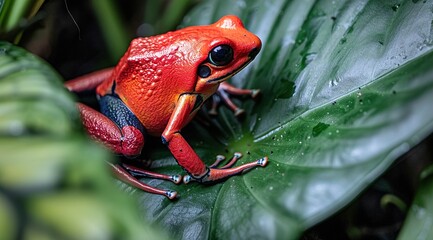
[192, 16, 261, 95]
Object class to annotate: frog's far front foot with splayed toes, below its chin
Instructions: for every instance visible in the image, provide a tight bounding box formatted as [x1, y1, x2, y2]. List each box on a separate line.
[209, 82, 260, 116]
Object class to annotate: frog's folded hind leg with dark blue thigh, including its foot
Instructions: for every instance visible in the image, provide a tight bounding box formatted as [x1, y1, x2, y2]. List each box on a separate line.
[78, 95, 181, 199]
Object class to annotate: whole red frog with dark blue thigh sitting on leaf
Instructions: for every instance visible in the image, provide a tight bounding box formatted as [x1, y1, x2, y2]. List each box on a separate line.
[65, 16, 268, 199]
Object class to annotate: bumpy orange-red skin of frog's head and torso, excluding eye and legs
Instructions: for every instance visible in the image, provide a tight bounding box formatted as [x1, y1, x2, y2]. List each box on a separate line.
[97, 16, 261, 136]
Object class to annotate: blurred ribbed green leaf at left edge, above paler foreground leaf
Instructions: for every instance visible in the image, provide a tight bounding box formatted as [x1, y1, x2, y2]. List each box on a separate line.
[0, 42, 79, 136]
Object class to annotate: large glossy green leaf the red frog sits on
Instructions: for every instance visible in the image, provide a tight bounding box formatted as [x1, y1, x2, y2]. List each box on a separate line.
[131, 0, 433, 239]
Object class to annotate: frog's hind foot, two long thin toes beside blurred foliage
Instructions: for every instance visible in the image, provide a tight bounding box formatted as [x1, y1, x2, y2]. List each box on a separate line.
[109, 163, 182, 199]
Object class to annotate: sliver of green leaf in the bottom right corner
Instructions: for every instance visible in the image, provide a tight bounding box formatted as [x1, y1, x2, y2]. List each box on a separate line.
[398, 166, 433, 240]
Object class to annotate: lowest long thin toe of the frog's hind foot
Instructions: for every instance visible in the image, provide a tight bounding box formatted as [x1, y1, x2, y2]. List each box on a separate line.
[109, 163, 180, 199]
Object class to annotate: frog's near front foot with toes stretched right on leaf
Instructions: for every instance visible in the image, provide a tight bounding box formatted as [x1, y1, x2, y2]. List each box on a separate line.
[183, 152, 268, 183]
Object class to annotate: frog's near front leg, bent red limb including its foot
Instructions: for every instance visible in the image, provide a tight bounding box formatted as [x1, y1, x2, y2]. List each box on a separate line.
[162, 93, 268, 183]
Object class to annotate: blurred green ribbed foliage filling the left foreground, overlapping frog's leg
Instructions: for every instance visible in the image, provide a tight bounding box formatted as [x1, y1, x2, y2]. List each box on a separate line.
[0, 42, 164, 239]
